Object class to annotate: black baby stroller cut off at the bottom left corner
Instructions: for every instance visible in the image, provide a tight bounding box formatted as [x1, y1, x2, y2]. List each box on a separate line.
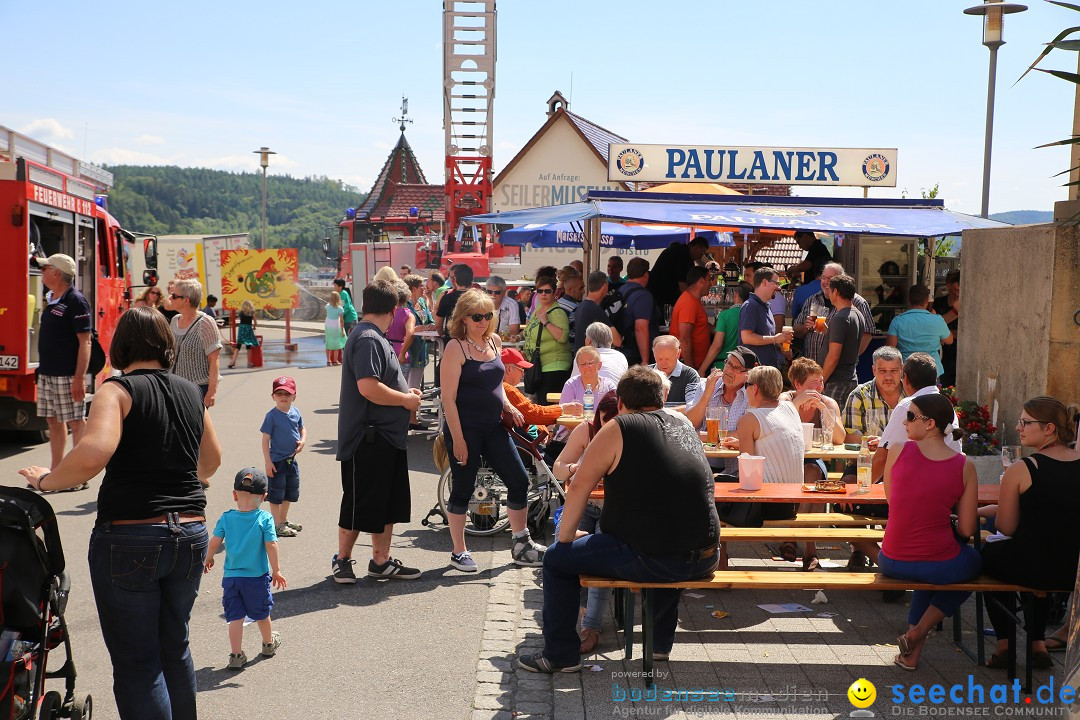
[0, 488, 93, 720]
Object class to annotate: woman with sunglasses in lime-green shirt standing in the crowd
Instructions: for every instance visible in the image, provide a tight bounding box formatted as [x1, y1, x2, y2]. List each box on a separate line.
[522, 275, 572, 405]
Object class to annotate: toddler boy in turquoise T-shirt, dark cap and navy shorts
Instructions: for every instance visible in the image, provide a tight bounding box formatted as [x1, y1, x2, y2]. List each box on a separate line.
[205, 467, 285, 670]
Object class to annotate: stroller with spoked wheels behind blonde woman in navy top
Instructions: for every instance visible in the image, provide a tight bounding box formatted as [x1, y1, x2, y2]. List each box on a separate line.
[421, 427, 566, 539]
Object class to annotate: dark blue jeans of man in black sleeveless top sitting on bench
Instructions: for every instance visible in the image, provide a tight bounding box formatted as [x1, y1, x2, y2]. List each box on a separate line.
[543, 533, 717, 667]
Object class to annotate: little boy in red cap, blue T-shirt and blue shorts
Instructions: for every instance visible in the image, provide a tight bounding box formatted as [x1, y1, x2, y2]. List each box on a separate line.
[260, 375, 308, 538]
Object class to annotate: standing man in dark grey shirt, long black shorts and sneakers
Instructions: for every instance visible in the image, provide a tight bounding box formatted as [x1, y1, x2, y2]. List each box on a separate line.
[330, 281, 420, 584]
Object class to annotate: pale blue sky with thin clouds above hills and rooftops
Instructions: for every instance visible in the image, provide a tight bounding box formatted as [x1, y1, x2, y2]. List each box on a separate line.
[6, 0, 1080, 214]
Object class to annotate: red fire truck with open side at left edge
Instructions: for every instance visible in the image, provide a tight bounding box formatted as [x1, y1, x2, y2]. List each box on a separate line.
[0, 126, 157, 440]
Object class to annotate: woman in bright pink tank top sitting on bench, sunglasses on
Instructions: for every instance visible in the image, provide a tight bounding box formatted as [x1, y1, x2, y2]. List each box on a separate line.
[878, 394, 982, 670]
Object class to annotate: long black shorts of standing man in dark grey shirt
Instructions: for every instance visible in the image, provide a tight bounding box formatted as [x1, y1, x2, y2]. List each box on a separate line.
[338, 433, 411, 533]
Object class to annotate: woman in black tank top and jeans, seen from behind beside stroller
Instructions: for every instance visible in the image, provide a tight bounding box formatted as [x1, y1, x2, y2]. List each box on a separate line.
[19, 308, 221, 720]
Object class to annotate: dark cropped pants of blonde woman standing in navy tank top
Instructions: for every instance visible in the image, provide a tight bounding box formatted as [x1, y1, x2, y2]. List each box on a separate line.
[443, 423, 529, 515]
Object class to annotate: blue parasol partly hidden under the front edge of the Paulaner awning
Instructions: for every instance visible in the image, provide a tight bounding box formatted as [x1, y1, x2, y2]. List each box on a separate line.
[499, 222, 734, 250]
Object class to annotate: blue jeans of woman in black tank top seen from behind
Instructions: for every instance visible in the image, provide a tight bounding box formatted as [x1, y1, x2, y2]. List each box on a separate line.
[90, 522, 210, 720]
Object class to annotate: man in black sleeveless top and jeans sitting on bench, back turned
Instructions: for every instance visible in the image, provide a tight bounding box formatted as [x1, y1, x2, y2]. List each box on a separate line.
[517, 366, 720, 673]
